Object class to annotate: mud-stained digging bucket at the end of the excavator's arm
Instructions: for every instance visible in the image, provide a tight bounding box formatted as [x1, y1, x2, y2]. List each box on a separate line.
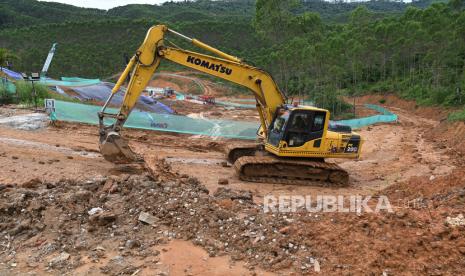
[99, 131, 137, 163]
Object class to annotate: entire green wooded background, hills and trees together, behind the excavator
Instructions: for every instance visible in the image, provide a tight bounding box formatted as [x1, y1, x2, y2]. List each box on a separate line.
[0, 0, 465, 116]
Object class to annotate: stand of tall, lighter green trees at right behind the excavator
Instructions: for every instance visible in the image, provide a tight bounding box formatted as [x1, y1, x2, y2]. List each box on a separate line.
[254, 0, 465, 112]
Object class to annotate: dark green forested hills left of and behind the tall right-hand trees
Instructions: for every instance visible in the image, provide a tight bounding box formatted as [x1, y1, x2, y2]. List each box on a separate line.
[0, 0, 442, 78]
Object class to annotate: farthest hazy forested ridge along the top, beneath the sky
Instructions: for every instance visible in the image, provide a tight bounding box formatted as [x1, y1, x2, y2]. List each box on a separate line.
[0, 0, 441, 29]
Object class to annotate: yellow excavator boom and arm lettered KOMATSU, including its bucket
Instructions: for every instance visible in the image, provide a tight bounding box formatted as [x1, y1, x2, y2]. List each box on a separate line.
[99, 25, 286, 162]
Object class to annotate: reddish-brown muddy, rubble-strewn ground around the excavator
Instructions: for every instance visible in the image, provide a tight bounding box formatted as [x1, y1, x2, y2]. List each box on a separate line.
[0, 84, 465, 275]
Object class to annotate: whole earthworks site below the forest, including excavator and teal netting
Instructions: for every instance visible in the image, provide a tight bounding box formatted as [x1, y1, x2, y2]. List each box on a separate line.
[0, 1, 465, 276]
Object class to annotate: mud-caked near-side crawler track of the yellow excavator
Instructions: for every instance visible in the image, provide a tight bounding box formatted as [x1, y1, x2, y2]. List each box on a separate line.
[234, 156, 349, 187]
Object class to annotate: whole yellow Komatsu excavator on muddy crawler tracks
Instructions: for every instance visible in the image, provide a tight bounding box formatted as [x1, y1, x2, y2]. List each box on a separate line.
[99, 25, 363, 186]
